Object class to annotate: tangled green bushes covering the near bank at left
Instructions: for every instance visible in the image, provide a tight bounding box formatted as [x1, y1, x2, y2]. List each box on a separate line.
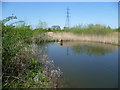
[1, 16, 49, 88]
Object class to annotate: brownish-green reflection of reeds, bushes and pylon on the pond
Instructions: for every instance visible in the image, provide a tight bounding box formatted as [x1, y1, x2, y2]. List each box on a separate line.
[62, 42, 117, 55]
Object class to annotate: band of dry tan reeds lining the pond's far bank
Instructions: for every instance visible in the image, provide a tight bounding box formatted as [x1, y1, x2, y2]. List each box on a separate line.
[46, 32, 118, 45]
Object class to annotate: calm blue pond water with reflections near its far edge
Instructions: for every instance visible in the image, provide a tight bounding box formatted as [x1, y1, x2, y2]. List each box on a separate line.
[44, 42, 118, 88]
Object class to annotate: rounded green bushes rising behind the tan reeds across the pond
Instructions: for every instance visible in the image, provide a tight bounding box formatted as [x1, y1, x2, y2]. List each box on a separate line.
[64, 24, 116, 35]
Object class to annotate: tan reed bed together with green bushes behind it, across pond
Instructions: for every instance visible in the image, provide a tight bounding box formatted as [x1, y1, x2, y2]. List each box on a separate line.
[48, 24, 119, 45]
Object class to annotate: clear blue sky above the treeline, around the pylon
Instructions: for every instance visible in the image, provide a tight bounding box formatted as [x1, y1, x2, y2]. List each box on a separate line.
[2, 2, 118, 28]
